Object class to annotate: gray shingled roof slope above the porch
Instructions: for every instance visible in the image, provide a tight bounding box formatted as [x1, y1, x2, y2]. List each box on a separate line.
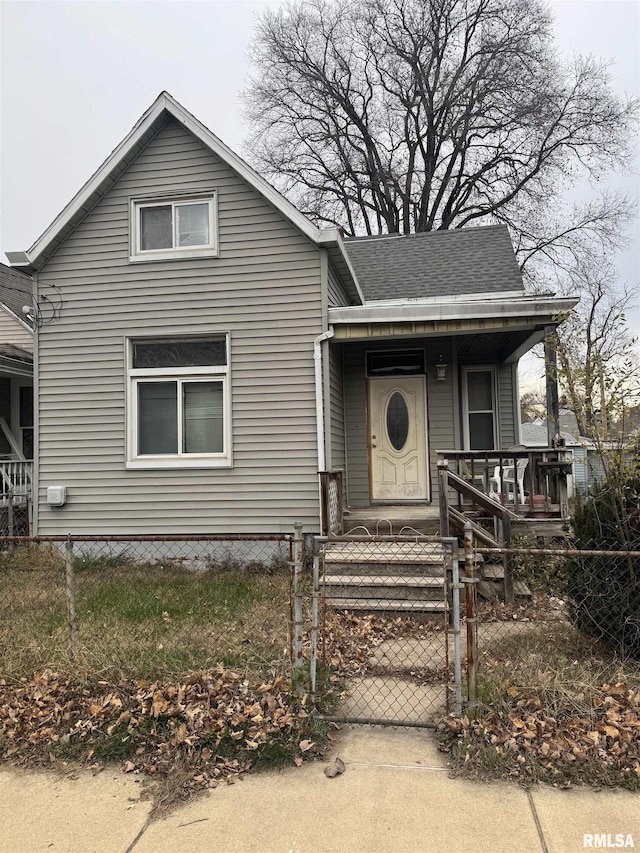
[345, 225, 524, 303]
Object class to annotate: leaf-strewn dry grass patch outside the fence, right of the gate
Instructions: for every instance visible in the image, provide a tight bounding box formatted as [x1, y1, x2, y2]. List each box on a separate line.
[443, 622, 640, 790]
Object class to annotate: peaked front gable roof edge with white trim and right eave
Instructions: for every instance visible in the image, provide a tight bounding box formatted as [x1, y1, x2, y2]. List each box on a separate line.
[6, 92, 363, 303]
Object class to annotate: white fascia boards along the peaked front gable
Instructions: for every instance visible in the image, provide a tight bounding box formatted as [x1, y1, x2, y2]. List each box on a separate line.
[17, 92, 328, 266]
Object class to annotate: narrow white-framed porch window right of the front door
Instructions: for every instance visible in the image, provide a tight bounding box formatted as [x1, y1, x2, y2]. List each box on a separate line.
[462, 366, 498, 450]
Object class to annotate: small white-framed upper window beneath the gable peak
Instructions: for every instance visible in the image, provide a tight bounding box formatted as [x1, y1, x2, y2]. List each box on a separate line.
[130, 192, 218, 261]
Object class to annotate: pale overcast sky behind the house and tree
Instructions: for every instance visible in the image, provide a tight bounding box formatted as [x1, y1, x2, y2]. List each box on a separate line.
[0, 0, 640, 360]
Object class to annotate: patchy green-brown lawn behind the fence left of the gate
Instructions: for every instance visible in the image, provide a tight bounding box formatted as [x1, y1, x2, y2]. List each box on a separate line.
[0, 545, 289, 682]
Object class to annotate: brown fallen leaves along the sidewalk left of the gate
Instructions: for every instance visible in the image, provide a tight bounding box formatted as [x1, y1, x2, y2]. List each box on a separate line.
[0, 665, 327, 811]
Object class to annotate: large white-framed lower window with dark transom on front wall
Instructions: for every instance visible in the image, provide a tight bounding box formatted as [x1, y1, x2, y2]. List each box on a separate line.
[127, 334, 232, 468]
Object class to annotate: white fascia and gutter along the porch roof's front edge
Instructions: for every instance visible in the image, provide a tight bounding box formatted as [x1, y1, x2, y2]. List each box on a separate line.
[329, 294, 579, 324]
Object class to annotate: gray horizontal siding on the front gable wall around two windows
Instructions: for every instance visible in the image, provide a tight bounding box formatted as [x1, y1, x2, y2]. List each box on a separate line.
[38, 120, 322, 534]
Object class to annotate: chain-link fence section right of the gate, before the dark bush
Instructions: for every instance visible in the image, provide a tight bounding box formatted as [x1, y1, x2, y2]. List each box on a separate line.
[463, 543, 640, 704]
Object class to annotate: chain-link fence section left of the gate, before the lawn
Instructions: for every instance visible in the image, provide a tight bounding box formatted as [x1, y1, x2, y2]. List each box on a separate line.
[0, 535, 291, 680]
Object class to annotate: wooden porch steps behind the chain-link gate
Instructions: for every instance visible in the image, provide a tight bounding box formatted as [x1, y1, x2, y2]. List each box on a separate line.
[324, 540, 446, 613]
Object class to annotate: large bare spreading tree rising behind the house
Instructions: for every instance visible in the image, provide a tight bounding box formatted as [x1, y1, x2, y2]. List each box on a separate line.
[244, 0, 638, 280]
